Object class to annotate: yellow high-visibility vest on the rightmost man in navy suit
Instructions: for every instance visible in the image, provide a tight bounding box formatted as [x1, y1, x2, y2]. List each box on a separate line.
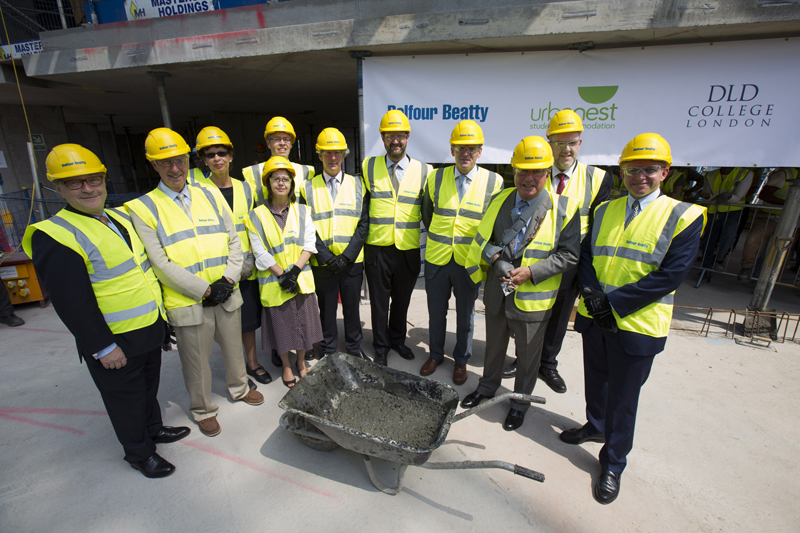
[578, 195, 706, 337]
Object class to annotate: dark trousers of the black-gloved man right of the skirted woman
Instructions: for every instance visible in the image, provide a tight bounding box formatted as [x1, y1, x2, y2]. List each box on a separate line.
[312, 264, 364, 354]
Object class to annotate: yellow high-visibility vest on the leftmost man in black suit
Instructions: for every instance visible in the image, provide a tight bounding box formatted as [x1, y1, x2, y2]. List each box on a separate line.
[22, 208, 167, 334]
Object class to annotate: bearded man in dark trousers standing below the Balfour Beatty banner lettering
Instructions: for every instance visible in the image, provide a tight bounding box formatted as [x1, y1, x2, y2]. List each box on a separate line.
[361, 109, 432, 365]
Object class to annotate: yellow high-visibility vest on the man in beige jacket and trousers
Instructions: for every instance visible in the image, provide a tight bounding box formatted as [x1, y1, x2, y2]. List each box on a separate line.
[125, 183, 230, 310]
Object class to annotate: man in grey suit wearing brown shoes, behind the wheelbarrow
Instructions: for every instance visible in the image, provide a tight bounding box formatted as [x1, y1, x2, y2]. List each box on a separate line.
[419, 120, 503, 385]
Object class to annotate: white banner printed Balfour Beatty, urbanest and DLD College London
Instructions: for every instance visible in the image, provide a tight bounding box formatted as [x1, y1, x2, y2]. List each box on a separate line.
[364, 38, 800, 166]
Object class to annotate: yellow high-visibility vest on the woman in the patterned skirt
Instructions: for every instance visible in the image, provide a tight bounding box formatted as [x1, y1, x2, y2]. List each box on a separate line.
[245, 202, 314, 307]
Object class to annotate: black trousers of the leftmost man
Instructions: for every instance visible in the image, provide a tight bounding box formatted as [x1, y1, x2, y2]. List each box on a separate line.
[84, 347, 162, 463]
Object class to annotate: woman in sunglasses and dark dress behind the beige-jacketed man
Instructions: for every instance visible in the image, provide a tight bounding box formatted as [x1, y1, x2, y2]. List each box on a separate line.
[192, 130, 272, 385]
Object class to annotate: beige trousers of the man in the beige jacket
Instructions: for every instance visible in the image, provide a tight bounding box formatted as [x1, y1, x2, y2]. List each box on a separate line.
[175, 305, 249, 422]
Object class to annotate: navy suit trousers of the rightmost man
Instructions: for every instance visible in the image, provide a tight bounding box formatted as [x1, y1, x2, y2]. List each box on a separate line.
[583, 324, 655, 474]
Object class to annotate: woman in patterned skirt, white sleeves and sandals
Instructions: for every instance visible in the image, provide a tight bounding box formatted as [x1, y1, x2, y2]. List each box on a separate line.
[245, 157, 322, 387]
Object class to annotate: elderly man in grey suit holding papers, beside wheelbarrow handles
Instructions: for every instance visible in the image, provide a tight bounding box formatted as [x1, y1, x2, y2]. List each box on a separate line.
[461, 136, 581, 431]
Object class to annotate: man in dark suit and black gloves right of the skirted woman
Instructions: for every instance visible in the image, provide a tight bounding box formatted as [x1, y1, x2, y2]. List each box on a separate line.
[300, 128, 369, 359]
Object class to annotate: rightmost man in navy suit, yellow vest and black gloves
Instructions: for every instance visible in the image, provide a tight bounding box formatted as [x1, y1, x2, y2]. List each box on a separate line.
[561, 133, 706, 504]
